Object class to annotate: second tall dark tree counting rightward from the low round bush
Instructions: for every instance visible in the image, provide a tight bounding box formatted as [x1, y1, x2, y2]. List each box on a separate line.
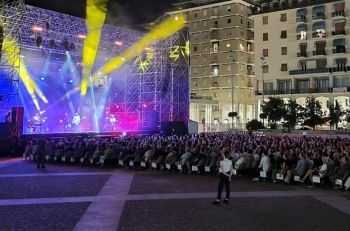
[283, 99, 304, 129]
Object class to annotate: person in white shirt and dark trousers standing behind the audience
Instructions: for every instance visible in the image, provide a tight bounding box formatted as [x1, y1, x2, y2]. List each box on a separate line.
[213, 151, 233, 205]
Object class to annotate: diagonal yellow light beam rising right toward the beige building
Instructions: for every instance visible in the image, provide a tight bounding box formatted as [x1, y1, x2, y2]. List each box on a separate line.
[92, 14, 186, 81]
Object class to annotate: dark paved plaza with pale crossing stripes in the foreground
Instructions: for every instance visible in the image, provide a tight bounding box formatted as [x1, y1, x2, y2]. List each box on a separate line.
[0, 159, 350, 231]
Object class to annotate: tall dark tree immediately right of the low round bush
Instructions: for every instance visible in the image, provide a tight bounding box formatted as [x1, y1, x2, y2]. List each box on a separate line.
[262, 97, 286, 127]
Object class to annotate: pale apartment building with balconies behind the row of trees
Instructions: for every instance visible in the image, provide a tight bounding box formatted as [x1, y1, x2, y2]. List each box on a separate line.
[253, 0, 350, 121]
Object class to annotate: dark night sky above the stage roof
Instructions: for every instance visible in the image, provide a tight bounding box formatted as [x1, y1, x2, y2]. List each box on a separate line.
[26, 0, 176, 25]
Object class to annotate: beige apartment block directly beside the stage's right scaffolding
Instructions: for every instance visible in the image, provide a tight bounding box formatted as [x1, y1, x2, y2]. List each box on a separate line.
[168, 0, 255, 131]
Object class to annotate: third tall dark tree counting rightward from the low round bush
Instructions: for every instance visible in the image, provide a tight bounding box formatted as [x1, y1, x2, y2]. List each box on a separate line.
[304, 97, 325, 130]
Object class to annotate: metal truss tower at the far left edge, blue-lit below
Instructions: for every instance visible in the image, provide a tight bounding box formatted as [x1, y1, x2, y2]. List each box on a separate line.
[0, 0, 25, 118]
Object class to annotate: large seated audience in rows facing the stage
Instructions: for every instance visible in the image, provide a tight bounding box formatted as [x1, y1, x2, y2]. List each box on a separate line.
[23, 133, 350, 190]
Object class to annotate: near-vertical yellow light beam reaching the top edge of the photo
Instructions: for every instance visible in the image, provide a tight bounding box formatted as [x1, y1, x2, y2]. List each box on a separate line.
[80, 0, 107, 95]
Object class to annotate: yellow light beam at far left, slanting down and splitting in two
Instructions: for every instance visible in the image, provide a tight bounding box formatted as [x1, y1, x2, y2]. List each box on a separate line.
[3, 37, 48, 110]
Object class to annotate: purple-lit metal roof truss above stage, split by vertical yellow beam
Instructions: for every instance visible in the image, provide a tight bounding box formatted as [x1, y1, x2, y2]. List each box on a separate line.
[17, 5, 143, 56]
